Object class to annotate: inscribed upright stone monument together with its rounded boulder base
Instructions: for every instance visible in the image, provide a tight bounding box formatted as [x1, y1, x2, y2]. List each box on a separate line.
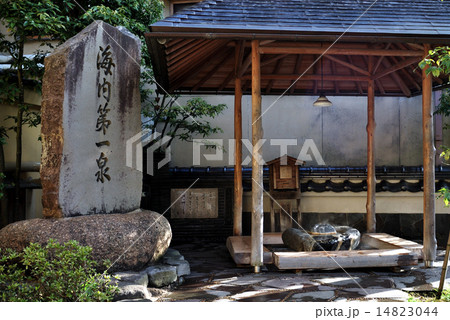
[0, 21, 172, 271]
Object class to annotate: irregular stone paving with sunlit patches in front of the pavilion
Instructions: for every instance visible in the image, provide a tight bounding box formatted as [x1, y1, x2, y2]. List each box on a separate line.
[139, 244, 450, 302]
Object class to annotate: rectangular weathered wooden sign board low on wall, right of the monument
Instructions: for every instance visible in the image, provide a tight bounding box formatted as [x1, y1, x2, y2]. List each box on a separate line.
[170, 188, 219, 219]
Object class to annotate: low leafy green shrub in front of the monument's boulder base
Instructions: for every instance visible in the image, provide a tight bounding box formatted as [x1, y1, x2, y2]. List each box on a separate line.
[0, 240, 118, 301]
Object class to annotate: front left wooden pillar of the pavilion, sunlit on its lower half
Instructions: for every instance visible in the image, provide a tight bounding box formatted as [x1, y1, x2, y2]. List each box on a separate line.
[250, 40, 264, 272]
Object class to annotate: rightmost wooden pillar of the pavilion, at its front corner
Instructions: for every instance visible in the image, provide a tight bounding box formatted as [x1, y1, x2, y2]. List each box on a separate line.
[422, 44, 437, 267]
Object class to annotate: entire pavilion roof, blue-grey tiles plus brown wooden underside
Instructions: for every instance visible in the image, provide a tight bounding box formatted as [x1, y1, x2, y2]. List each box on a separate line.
[146, 0, 450, 96]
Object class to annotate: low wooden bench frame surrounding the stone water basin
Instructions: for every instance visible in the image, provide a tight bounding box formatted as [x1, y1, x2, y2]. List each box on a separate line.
[227, 233, 422, 270]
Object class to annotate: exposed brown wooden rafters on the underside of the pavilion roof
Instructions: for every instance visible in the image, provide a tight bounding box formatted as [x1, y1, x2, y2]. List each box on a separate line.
[159, 39, 443, 96]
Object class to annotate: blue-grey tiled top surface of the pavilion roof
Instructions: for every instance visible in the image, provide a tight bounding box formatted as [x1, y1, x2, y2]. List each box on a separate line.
[152, 0, 450, 36]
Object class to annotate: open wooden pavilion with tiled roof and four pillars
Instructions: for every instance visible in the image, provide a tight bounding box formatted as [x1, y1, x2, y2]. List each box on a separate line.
[146, 0, 450, 271]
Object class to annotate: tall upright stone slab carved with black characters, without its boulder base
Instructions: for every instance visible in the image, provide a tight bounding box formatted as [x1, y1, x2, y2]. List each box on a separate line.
[41, 21, 142, 217]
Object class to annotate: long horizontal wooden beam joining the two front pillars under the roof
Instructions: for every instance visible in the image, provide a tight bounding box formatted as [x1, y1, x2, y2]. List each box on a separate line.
[259, 47, 422, 57]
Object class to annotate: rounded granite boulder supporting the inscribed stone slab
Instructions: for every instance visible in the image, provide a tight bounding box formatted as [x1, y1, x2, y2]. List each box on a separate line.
[0, 210, 172, 271]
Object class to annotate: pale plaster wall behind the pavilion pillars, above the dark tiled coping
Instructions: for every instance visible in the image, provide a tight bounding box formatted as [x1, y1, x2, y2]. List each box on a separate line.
[171, 96, 442, 167]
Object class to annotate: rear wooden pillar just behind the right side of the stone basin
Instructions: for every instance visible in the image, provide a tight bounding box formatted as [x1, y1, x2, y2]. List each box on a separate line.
[366, 56, 377, 233]
